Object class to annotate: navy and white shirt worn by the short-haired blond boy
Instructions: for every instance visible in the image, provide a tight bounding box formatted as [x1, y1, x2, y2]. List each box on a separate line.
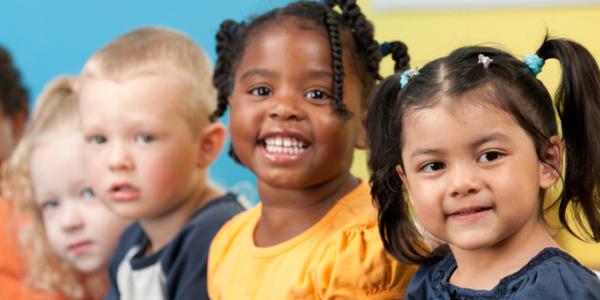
[105, 193, 244, 300]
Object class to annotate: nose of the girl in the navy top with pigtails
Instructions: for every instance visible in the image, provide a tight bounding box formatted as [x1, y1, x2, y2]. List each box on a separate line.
[449, 164, 483, 198]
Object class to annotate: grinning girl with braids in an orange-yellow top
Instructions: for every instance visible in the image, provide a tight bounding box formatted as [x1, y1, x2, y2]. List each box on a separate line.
[208, 1, 414, 299]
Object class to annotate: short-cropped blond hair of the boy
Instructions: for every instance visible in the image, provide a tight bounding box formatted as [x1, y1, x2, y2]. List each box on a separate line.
[82, 27, 217, 130]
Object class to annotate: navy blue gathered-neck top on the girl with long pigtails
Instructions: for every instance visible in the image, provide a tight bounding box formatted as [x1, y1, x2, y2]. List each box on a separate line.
[405, 248, 600, 300]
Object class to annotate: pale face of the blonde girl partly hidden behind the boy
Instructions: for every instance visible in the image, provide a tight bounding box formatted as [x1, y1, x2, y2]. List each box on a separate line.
[30, 131, 128, 273]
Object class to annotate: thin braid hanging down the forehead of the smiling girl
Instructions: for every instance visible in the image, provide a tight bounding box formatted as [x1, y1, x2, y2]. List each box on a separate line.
[325, 9, 351, 118]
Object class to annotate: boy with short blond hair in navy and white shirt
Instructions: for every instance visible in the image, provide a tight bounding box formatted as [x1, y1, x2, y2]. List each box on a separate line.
[80, 27, 243, 299]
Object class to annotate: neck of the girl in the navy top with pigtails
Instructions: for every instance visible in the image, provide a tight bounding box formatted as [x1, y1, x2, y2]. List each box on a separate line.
[450, 220, 558, 290]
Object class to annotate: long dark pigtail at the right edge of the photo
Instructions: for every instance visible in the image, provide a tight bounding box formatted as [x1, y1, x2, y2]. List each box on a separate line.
[537, 37, 600, 241]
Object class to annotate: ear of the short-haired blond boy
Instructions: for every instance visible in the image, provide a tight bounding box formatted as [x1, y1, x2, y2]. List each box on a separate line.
[197, 122, 225, 168]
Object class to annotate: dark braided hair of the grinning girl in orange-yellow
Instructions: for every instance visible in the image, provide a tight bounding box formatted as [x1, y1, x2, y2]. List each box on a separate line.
[210, 0, 408, 162]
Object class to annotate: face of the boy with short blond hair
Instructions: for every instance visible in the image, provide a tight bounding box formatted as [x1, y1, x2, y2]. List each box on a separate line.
[80, 75, 202, 220]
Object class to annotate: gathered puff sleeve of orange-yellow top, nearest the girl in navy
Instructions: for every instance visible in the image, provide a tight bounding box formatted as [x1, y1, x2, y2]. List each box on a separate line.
[316, 187, 415, 299]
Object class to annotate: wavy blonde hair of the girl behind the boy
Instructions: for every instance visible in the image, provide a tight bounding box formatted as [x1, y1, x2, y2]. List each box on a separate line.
[2, 76, 86, 299]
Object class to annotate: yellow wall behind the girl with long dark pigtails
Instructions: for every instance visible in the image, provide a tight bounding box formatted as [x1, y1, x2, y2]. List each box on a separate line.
[353, 0, 600, 270]
